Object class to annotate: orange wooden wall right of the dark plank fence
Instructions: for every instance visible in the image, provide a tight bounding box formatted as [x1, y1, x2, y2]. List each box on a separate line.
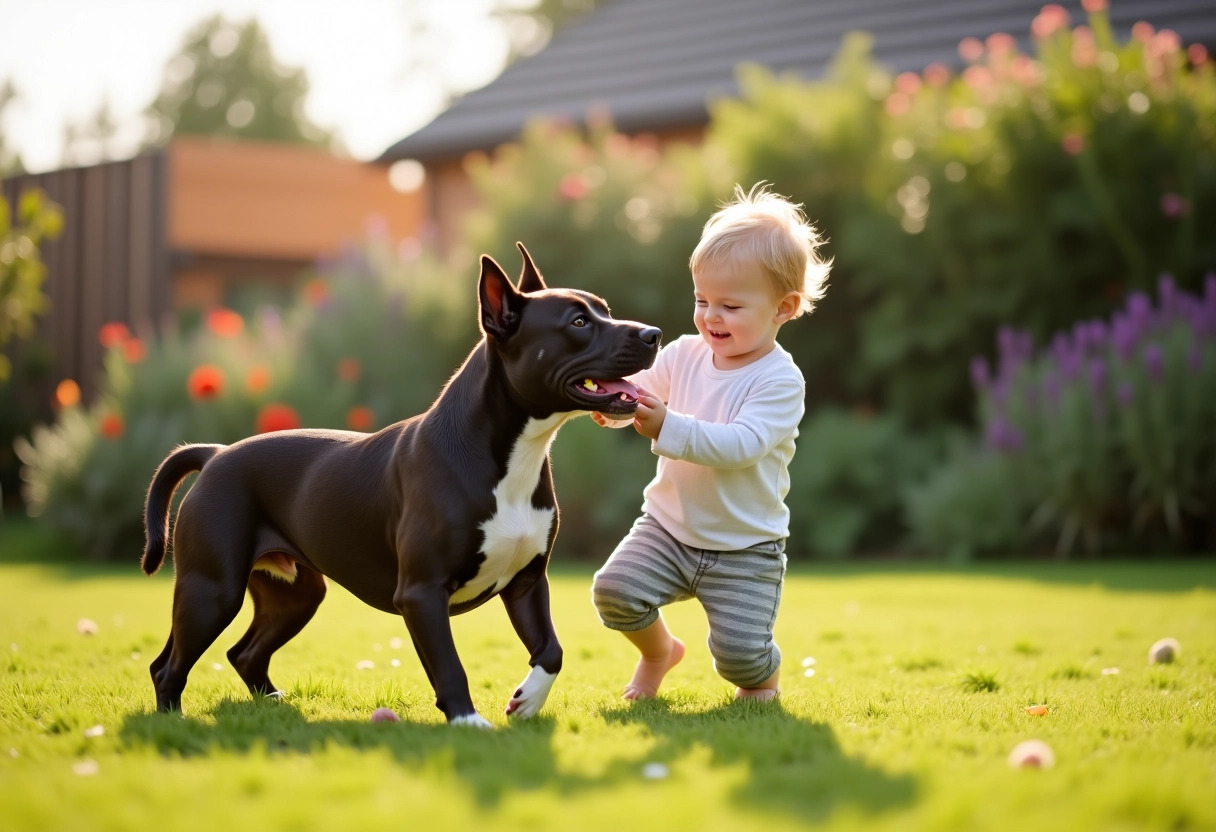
[168, 137, 422, 260]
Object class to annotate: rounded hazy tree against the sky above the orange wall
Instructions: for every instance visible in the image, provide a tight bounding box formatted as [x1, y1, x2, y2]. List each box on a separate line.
[146, 16, 334, 146]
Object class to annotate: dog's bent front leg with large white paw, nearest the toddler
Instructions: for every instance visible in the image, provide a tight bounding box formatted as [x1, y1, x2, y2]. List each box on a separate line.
[502, 556, 562, 719]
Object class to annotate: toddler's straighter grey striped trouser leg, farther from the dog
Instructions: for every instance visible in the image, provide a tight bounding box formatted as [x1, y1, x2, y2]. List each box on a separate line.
[697, 541, 786, 687]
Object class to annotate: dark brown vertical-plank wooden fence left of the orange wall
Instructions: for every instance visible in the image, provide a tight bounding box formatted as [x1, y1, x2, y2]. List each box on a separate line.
[0, 151, 173, 400]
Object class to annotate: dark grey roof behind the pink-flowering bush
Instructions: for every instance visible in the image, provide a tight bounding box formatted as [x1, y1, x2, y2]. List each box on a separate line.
[382, 0, 1216, 161]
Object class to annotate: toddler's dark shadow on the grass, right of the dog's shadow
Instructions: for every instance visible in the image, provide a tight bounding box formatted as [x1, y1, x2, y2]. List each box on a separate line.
[603, 698, 917, 822]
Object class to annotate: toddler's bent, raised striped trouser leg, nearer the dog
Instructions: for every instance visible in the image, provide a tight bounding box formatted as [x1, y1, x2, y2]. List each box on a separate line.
[591, 515, 698, 630]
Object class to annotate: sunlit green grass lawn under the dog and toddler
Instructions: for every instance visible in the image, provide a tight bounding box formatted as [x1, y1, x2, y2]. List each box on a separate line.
[0, 523, 1216, 832]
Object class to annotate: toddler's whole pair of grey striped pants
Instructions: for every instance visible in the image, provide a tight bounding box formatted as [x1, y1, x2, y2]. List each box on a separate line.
[591, 515, 786, 687]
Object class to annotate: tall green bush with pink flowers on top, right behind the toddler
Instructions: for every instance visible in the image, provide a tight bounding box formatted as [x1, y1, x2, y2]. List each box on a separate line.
[709, 10, 1216, 425]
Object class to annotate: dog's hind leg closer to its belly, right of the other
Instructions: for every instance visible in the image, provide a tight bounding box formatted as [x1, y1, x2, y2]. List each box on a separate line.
[227, 563, 325, 696]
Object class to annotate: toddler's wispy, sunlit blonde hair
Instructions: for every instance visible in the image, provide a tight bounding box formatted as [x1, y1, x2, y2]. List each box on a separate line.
[688, 182, 832, 320]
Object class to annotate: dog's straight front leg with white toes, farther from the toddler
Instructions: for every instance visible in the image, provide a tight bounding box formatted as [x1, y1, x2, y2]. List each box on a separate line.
[393, 583, 494, 727]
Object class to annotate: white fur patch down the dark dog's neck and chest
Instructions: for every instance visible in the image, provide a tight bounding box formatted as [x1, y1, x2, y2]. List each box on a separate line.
[451, 414, 574, 603]
